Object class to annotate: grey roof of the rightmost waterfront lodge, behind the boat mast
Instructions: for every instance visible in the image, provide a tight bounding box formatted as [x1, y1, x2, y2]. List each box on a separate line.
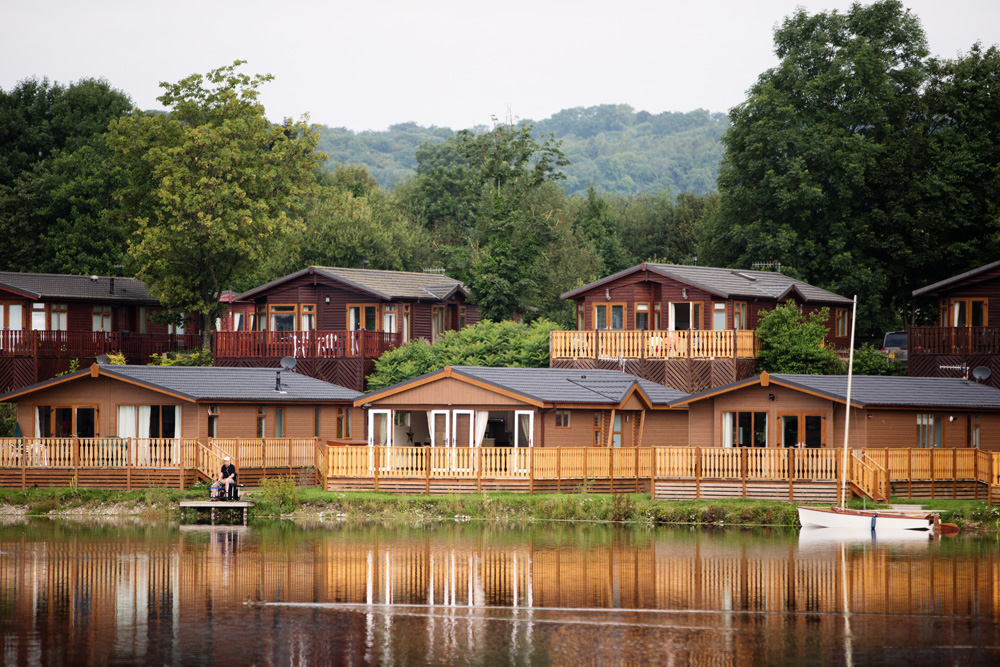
[672, 373, 1000, 409]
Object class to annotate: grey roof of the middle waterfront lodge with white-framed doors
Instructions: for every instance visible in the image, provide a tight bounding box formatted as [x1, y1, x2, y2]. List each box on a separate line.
[366, 366, 684, 406]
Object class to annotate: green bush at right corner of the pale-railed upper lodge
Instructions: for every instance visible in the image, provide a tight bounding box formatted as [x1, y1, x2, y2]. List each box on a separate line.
[757, 302, 844, 375]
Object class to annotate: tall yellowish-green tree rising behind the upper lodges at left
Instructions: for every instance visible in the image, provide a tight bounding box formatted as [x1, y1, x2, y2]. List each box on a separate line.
[111, 61, 324, 348]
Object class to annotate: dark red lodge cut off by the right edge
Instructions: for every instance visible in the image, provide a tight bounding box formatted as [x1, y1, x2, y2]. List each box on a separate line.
[907, 261, 1000, 388]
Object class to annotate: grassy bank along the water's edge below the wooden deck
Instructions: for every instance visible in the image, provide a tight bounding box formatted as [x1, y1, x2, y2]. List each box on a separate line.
[0, 481, 1000, 530]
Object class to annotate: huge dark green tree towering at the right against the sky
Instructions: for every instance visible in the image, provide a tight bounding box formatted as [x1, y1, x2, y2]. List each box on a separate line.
[707, 0, 1000, 335]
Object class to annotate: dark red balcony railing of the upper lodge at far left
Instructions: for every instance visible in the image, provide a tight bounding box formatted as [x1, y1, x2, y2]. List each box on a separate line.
[0, 329, 199, 363]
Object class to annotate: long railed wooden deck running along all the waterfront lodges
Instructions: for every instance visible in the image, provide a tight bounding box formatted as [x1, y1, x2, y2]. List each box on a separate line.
[0, 438, 1000, 502]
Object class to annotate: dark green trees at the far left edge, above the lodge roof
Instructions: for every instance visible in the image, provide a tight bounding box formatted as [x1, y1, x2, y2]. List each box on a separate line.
[0, 79, 132, 275]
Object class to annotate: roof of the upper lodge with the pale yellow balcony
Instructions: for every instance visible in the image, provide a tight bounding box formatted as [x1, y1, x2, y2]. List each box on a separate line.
[560, 263, 851, 304]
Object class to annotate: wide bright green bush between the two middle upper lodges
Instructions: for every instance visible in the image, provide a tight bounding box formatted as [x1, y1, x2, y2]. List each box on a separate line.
[368, 320, 558, 391]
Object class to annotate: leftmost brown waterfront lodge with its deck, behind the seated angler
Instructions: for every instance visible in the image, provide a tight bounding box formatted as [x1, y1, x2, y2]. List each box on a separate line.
[0, 364, 364, 489]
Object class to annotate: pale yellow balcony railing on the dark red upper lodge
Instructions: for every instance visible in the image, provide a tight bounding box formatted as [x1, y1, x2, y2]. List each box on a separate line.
[549, 330, 757, 359]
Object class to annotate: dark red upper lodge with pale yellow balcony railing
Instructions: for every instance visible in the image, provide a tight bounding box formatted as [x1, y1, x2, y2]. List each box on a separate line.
[549, 263, 851, 393]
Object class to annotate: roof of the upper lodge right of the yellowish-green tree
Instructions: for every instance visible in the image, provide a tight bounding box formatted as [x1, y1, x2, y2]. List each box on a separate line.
[239, 266, 468, 301]
